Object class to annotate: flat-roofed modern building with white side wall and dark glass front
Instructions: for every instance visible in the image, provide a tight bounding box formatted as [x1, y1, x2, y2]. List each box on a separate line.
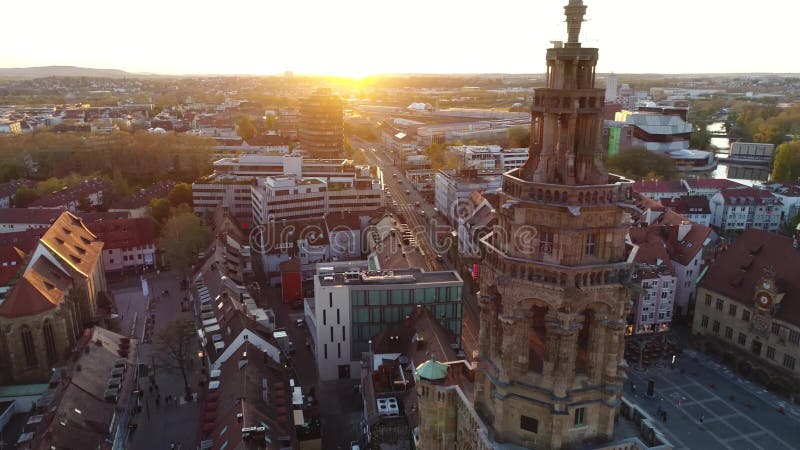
[306, 258, 463, 381]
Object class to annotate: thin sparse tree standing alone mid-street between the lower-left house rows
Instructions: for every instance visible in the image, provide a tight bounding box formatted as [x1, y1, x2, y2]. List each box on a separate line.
[154, 319, 195, 400]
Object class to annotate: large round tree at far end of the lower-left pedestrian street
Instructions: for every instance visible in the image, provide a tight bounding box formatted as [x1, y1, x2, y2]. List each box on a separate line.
[158, 204, 212, 270]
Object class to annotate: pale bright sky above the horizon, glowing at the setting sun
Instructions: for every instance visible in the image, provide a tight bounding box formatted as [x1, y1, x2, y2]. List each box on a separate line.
[0, 0, 800, 76]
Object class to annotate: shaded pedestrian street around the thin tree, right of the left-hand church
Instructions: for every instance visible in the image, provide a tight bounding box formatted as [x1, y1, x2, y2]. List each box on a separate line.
[110, 272, 205, 450]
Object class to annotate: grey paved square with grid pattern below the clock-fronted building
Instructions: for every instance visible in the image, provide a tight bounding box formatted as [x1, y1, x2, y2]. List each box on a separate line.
[625, 350, 800, 450]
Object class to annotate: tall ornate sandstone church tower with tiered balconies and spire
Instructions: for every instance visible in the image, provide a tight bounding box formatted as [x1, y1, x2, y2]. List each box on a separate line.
[475, 0, 633, 449]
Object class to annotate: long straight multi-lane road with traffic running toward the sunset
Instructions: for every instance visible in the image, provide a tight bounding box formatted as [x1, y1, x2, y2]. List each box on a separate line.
[350, 136, 479, 360]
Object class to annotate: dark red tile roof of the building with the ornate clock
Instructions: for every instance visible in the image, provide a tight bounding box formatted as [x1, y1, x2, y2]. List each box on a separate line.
[700, 229, 800, 326]
